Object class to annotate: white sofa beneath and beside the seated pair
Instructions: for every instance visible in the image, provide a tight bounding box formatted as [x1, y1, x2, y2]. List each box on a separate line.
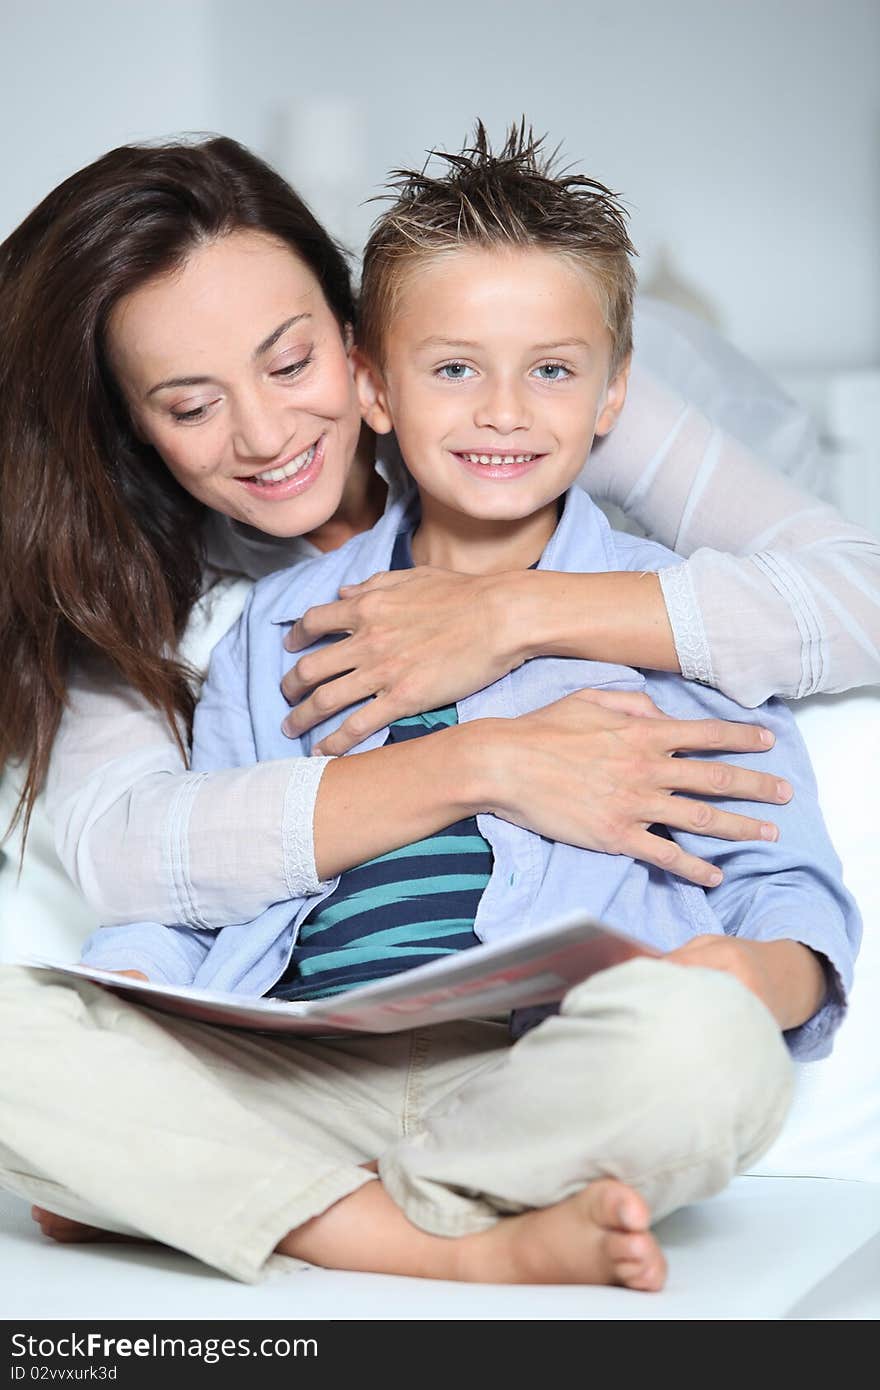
[0, 692, 880, 1321]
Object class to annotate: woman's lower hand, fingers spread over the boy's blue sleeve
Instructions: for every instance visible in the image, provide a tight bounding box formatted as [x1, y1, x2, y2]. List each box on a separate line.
[481, 691, 791, 887]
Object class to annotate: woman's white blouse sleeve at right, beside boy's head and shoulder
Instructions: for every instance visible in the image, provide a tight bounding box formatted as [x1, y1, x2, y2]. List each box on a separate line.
[582, 308, 880, 708]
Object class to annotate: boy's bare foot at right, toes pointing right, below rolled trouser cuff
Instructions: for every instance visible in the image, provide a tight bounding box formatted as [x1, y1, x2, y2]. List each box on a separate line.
[460, 1179, 666, 1293]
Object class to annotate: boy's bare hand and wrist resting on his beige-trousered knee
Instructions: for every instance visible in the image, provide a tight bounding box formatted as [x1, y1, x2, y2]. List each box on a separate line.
[663, 935, 826, 1029]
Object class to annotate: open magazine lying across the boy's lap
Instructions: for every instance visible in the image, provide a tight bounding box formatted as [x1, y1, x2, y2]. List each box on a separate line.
[25, 916, 658, 1037]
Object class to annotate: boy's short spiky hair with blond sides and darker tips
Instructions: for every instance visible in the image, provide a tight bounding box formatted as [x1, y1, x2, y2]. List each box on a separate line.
[357, 120, 635, 373]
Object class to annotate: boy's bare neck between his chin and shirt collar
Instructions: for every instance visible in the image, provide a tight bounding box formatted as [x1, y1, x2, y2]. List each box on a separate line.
[412, 492, 559, 574]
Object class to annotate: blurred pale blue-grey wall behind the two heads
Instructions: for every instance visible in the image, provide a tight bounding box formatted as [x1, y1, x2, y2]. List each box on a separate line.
[0, 0, 880, 528]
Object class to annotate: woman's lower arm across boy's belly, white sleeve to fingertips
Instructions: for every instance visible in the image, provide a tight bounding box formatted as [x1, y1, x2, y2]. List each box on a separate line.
[46, 647, 787, 929]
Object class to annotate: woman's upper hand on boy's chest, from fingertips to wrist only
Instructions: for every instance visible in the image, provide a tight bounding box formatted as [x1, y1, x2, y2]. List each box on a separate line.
[281, 566, 525, 755]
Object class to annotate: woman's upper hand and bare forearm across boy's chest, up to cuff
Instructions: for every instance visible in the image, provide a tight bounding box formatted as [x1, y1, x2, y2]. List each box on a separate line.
[281, 566, 678, 755]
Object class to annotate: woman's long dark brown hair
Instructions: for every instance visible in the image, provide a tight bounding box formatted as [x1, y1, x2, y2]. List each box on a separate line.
[0, 139, 355, 837]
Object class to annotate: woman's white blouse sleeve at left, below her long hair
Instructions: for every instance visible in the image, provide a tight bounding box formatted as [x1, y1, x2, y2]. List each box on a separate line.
[46, 581, 328, 929]
